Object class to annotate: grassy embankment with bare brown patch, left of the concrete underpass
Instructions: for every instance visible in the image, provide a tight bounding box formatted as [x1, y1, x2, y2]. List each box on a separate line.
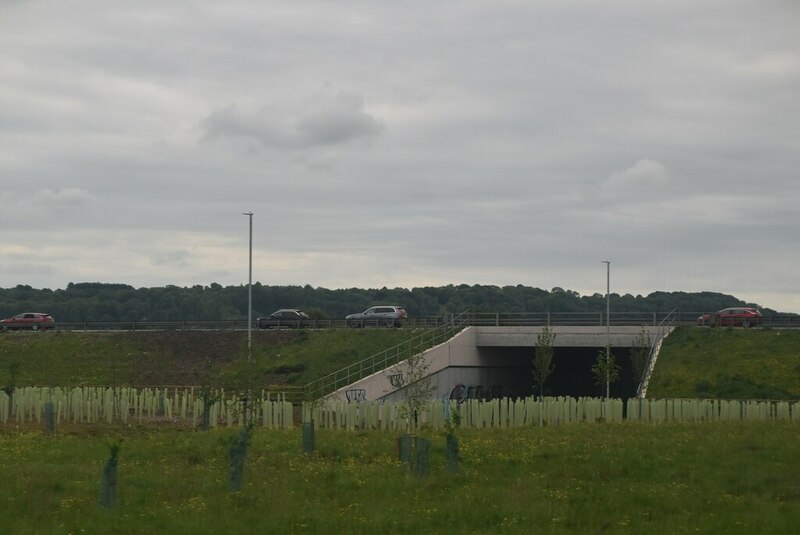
[0, 329, 420, 388]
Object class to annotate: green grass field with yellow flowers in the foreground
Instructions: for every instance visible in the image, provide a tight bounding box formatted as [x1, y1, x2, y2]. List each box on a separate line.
[0, 422, 800, 534]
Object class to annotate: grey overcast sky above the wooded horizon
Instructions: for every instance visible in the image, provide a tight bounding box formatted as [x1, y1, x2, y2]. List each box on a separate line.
[0, 0, 800, 312]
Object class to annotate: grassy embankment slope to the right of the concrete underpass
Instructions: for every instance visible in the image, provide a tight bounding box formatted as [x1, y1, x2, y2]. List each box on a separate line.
[647, 327, 800, 399]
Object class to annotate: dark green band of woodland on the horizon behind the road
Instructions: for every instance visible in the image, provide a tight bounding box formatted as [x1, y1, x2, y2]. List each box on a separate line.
[0, 282, 776, 322]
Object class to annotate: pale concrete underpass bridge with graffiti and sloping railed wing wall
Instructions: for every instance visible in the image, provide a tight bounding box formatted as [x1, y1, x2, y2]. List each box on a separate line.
[318, 317, 675, 402]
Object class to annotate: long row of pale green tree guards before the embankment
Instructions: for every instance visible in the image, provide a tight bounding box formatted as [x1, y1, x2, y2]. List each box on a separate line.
[0, 387, 800, 431]
